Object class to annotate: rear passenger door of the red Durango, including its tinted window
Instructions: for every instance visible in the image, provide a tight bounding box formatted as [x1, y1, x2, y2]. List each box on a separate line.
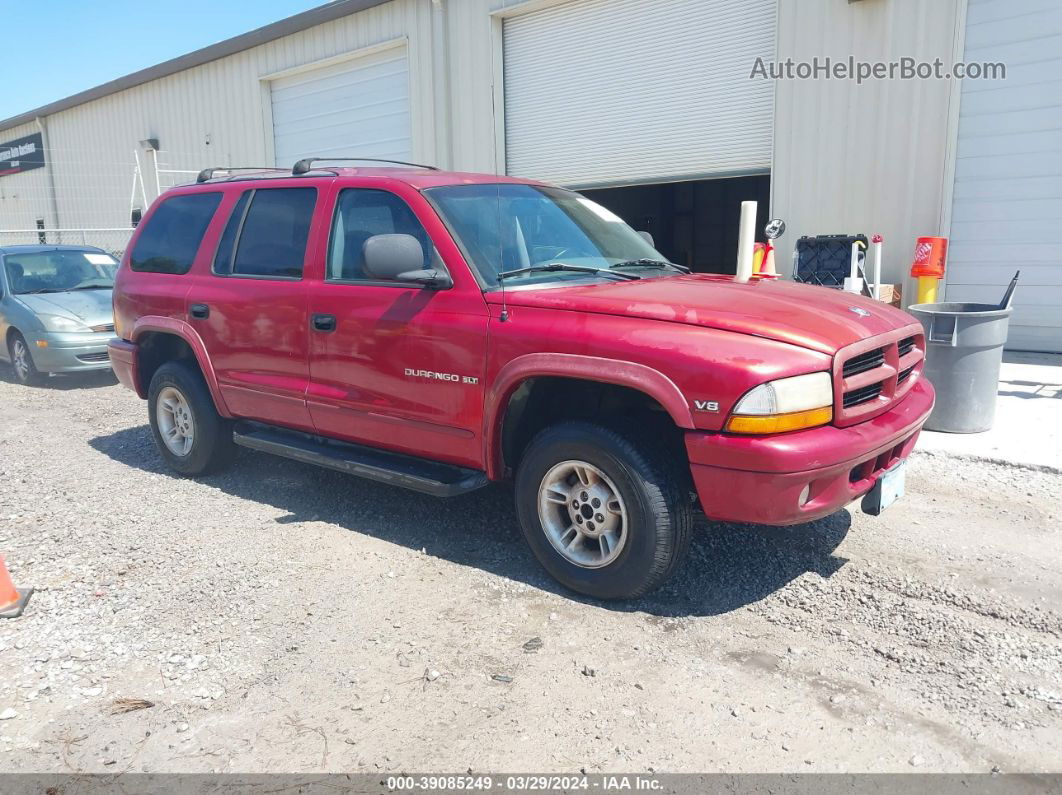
[187, 180, 318, 431]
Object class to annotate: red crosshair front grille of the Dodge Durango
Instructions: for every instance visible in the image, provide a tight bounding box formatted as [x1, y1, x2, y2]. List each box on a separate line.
[834, 330, 925, 428]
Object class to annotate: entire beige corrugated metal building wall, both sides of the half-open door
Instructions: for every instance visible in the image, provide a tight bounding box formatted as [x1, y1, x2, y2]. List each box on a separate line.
[0, 0, 965, 290]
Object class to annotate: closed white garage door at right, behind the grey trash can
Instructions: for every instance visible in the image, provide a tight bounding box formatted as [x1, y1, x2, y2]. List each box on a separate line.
[945, 0, 1062, 351]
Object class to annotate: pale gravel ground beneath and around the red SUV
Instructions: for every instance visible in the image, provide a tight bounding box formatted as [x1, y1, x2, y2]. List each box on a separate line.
[0, 373, 1062, 773]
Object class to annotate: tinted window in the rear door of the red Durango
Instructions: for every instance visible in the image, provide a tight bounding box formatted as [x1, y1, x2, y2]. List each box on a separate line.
[213, 188, 318, 279]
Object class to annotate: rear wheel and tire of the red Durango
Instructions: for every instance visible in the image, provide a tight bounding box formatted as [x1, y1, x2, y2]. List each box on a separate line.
[148, 362, 235, 476]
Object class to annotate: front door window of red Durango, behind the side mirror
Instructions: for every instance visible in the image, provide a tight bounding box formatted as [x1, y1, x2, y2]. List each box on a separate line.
[326, 188, 434, 281]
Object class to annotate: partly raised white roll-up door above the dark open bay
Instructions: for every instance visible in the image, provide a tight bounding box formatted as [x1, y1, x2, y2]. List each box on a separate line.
[502, 0, 777, 186]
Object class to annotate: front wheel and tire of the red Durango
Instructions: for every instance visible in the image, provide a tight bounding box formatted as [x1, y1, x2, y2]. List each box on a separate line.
[516, 422, 692, 599]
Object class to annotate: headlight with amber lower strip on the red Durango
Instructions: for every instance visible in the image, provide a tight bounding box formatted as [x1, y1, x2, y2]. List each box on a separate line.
[726, 373, 834, 433]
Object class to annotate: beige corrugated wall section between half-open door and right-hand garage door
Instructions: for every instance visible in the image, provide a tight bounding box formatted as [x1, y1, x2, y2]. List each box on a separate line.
[771, 0, 965, 281]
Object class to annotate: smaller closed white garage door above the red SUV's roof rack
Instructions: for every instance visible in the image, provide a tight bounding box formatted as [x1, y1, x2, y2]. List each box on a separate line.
[271, 46, 412, 167]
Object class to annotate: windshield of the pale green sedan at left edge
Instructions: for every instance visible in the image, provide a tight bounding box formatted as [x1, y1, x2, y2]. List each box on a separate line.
[3, 249, 118, 295]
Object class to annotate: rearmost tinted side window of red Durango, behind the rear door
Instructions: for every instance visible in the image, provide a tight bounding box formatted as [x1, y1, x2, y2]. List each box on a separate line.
[130, 193, 221, 274]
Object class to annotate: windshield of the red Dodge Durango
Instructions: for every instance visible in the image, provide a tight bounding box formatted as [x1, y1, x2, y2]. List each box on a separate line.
[425, 185, 667, 287]
